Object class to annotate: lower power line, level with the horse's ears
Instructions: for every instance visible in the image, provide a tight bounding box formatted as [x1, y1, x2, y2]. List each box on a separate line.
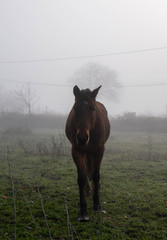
[0, 79, 167, 88]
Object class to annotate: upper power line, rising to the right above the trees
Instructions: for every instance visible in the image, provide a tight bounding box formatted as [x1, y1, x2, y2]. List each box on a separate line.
[0, 47, 167, 64]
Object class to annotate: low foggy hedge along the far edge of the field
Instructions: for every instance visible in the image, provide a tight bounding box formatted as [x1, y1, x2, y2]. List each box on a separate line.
[0, 112, 167, 134]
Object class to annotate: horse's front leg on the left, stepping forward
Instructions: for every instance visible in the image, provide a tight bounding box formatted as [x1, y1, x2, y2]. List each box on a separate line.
[72, 148, 89, 221]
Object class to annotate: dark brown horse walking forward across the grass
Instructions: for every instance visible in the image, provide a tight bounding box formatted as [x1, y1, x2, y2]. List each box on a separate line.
[65, 86, 110, 221]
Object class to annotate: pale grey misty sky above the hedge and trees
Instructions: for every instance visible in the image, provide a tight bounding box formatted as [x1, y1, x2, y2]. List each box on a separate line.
[0, 0, 167, 115]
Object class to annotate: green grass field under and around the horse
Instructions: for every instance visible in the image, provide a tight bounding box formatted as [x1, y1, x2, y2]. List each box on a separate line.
[0, 131, 167, 240]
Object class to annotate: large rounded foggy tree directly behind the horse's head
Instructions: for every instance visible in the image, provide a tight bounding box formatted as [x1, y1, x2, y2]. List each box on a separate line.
[71, 63, 121, 101]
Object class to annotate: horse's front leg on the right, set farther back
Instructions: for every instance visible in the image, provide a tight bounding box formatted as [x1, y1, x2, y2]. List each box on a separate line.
[92, 147, 104, 211]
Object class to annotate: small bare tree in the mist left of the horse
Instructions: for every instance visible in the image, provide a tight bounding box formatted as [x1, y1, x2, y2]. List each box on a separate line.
[16, 83, 38, 116]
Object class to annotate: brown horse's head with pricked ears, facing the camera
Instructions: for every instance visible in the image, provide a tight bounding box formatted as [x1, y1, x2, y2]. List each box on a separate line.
[73, 86, 101, 145]
